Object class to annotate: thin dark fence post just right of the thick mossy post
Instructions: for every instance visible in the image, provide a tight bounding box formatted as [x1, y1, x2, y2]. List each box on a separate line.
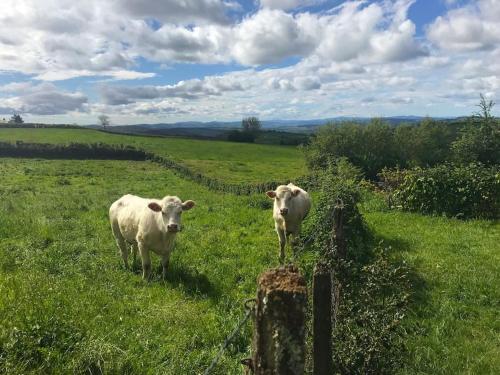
[313, 262, 333, 375]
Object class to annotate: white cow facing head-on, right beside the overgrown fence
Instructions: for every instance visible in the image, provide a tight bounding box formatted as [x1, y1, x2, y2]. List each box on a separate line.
[266, 183, 311, 263]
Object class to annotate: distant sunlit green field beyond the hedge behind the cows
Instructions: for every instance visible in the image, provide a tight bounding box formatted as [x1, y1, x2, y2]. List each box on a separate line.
[0, 128, 305, 182]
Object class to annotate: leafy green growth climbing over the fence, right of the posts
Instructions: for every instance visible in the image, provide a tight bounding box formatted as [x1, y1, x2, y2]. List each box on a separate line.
[296, 159, 410, 374]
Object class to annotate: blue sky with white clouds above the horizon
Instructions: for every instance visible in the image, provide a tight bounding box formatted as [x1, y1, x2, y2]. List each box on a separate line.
[0, 0, 500, 124]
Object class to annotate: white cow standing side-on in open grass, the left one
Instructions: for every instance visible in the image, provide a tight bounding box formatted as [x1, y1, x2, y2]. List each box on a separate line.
[109, 194, 195, 279]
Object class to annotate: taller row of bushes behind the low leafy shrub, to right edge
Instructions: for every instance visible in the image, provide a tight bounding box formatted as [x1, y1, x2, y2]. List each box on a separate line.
[303, 96, 500, 180]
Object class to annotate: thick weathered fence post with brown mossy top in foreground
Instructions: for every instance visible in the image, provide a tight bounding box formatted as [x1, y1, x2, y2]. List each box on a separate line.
[252, 265, 307, 375]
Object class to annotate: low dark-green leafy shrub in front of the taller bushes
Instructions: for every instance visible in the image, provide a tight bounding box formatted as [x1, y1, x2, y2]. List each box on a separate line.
[393, 163, 500, 218]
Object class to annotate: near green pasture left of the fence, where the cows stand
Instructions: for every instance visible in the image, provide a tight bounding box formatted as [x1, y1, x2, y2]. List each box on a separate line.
[0, 159, 277, 374]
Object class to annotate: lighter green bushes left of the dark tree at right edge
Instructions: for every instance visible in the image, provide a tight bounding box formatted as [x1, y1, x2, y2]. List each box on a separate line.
[303, 119, 461, 179]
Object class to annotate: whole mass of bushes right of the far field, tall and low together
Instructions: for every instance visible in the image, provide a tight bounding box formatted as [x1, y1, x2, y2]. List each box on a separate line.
[303, 95, 500, 219]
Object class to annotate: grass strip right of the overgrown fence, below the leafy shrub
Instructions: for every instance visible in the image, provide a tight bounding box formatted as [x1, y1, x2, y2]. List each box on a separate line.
[364, 206, 500, 374]
